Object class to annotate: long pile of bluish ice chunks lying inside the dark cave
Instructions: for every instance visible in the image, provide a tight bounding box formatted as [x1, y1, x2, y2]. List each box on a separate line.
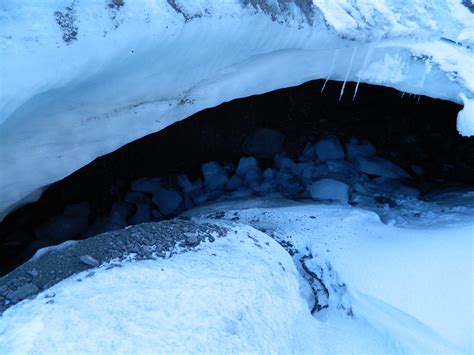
[30, 137, 420, 248]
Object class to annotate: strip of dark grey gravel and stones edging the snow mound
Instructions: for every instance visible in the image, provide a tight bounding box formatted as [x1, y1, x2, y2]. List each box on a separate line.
[0, 218, 227, 314]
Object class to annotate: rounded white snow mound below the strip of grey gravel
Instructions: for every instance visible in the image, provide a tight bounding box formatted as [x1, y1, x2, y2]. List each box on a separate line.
[0, 227, 319, 354]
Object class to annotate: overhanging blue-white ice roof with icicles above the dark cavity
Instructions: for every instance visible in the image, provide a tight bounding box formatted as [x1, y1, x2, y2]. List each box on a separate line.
[0, 0, 474, 220]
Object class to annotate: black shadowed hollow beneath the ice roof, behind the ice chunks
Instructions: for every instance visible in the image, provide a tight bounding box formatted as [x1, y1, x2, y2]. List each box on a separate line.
[0, 80, 474, 274]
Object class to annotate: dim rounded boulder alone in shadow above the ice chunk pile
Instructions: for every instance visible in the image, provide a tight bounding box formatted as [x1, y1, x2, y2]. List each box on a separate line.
[244, 128, 285, 159]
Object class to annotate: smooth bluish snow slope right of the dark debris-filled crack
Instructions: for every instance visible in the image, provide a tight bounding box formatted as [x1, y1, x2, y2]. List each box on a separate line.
[188, 200, 474, 354]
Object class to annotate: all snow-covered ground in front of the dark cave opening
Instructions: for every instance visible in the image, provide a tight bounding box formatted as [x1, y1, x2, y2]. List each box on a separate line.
[0, 199, 474, 354]
